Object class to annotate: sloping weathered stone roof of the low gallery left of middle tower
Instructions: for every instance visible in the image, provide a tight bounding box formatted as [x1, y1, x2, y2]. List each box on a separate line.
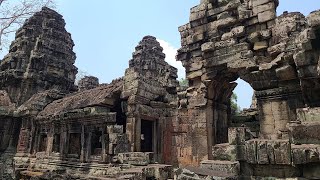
[38, 78, 123, 119]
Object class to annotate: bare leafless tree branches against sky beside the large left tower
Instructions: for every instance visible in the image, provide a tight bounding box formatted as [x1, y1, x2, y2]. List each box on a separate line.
[0, 0, 55, 51]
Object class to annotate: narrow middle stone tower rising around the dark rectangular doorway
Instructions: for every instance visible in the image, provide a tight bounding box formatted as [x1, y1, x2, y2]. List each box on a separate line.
[121, 36, 178, 160]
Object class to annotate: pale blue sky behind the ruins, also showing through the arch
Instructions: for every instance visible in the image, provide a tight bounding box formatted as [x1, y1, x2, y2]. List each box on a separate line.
[3, 0, 320, 107]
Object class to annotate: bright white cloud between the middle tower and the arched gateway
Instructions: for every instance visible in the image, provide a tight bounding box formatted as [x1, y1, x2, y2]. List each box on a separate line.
[157, 39, 186, 79]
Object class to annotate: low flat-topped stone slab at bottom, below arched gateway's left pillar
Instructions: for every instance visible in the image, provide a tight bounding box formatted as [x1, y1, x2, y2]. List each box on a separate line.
[200, 160, 240, 177]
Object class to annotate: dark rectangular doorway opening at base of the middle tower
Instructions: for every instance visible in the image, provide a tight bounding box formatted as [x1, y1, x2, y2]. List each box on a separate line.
[141, 120, 154, 152]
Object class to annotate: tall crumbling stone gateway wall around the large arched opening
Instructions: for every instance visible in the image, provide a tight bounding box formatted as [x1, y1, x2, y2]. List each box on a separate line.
[177, 0, 320, 165]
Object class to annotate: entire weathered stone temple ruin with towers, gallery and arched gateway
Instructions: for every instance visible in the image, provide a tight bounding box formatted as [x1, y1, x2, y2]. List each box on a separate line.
[0, 0, 320, 180]
